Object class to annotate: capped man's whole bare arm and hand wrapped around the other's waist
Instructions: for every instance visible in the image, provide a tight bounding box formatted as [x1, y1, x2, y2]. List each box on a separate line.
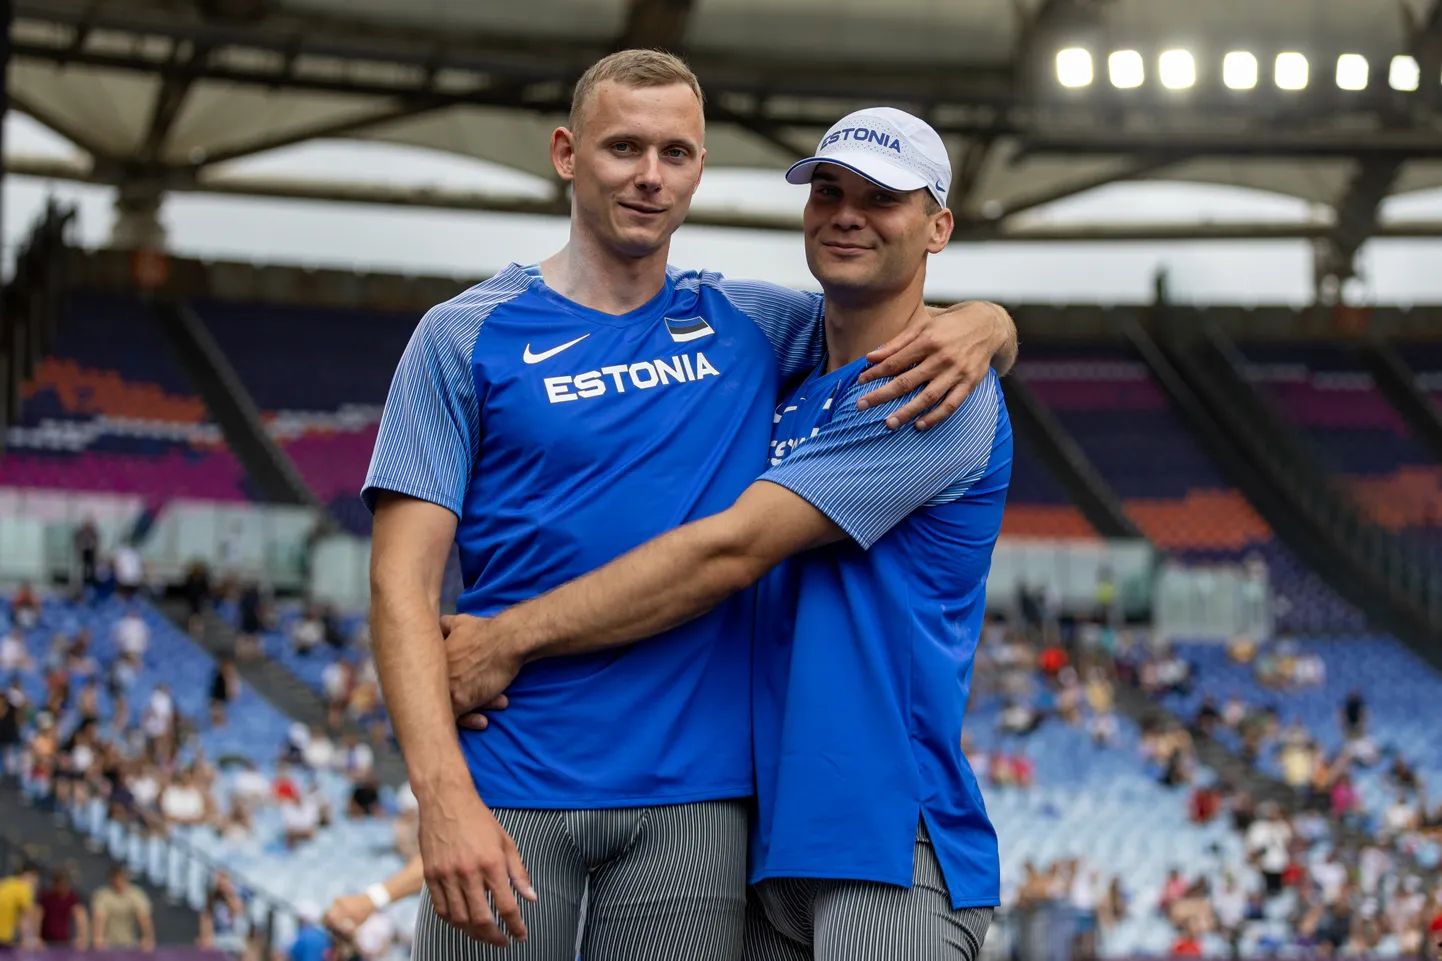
[446, 481, 845, 718]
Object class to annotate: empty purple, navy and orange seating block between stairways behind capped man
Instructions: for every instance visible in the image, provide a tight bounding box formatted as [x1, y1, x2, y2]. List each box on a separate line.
[1017, 345, 1364, 632]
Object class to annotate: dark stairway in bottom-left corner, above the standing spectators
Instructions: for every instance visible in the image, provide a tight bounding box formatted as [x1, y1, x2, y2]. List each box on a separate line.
[0, 785, 200, 945]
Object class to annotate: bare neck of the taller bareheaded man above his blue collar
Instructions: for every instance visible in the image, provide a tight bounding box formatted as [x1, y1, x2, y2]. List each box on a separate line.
[541, 219, 671, 315]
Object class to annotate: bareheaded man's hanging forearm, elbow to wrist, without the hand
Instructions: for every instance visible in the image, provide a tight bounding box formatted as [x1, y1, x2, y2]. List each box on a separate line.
[371, 571, 467, 798]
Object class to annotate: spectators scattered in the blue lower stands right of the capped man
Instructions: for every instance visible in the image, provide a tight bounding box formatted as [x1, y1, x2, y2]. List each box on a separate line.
[963, 588, 1442, 958]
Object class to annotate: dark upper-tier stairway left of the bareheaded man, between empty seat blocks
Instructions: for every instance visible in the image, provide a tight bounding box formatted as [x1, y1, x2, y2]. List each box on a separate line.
[153, 302, 329, 518]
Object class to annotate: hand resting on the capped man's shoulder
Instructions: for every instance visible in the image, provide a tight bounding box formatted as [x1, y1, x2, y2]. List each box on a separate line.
[857, 300, 1017, 430]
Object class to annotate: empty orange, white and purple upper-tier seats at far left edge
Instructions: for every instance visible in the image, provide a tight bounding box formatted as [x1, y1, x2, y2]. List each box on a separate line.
[0, 294, 247, 504]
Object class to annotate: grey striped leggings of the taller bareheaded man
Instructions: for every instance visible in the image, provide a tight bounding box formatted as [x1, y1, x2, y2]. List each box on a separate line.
[411, 801, 747, 961]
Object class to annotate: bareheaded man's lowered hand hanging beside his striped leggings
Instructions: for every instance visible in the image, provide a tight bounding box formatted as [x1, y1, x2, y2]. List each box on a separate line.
[420, 781, 536, 948]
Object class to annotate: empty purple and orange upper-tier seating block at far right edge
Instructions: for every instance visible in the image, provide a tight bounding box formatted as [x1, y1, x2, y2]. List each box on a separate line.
[1244, 343, 1442, 557]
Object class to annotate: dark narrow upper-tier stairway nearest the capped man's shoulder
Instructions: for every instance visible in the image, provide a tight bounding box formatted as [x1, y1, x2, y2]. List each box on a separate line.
[1001, 374, 1142, 538]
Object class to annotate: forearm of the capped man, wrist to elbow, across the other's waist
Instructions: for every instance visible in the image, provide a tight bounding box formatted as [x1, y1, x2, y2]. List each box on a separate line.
[495, 514, 769, 659]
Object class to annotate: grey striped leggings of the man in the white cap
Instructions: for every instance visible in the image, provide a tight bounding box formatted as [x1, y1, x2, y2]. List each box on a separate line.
[746, 825, 992, 961]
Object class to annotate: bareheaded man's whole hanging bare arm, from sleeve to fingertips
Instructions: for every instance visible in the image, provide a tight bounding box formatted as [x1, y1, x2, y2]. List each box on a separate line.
[371, 495, 535, 948]
